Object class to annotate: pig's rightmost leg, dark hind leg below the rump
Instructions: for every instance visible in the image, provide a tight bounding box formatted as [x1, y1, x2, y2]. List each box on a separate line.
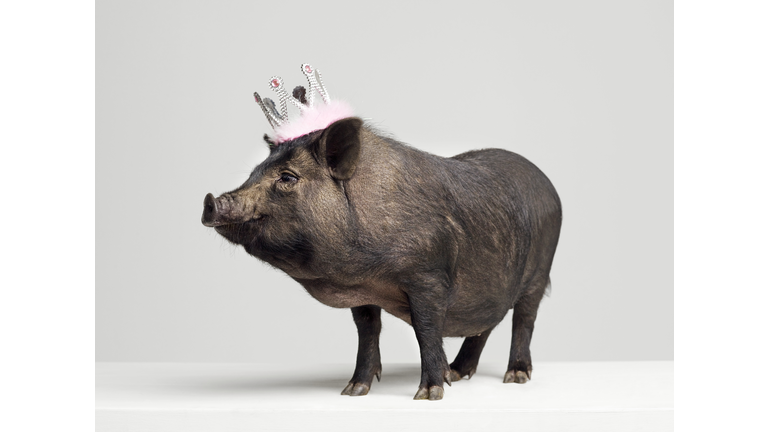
[504, 278, 549, 384]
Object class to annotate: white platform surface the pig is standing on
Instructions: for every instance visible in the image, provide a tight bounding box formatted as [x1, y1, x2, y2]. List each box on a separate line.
[96, 361, 673, 432]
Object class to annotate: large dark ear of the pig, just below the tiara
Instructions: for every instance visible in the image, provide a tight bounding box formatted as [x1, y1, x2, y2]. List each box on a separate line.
[317, 117, 363, 180]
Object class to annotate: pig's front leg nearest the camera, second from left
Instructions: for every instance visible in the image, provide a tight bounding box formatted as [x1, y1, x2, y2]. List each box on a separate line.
[408, 282, 451, 400]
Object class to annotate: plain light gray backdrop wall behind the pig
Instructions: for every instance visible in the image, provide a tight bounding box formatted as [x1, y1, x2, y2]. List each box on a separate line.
[96, 0, 673, 364]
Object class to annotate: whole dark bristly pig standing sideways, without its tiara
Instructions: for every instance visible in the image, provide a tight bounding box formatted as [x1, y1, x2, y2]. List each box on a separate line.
[202, 117, 562, 400]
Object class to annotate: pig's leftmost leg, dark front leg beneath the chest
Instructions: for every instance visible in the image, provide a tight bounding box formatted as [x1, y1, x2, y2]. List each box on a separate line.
[341, 306, 381, 396]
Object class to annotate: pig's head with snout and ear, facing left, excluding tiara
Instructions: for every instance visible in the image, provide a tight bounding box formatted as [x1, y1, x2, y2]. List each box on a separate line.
[202, 117, 363, 276]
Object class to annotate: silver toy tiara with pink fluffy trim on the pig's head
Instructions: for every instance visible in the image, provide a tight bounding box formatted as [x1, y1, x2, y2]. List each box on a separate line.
[253, 63, 354, 145]
